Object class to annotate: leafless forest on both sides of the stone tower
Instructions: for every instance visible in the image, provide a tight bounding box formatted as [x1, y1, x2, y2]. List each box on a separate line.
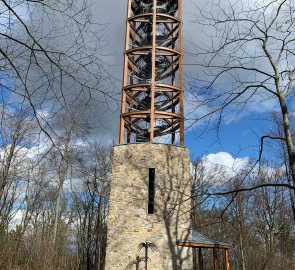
[0, 0, 295, 270]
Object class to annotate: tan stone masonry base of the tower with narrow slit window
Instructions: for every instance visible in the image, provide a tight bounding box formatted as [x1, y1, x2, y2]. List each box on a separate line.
[105, 144, 192, 270]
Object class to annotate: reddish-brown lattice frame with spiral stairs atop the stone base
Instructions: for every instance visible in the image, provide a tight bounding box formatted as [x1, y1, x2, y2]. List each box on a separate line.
[120, 0, 184, 146]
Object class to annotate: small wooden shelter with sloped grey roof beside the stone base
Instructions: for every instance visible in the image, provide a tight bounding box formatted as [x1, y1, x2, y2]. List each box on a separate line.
[177, 230, 229, 270]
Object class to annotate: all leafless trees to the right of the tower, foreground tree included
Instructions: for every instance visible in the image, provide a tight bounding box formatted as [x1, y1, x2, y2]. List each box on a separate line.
[191, 0, 295, 270]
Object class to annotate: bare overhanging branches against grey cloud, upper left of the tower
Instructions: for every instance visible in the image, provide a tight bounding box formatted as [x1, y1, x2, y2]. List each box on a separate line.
[0, 0, 113, 146]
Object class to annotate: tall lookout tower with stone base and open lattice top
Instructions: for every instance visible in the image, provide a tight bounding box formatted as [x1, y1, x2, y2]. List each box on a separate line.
[105, 0, 192, 270]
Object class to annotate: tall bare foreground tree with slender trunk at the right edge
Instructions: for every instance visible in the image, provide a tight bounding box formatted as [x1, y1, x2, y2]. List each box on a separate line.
[191, 0, 295, 182]
